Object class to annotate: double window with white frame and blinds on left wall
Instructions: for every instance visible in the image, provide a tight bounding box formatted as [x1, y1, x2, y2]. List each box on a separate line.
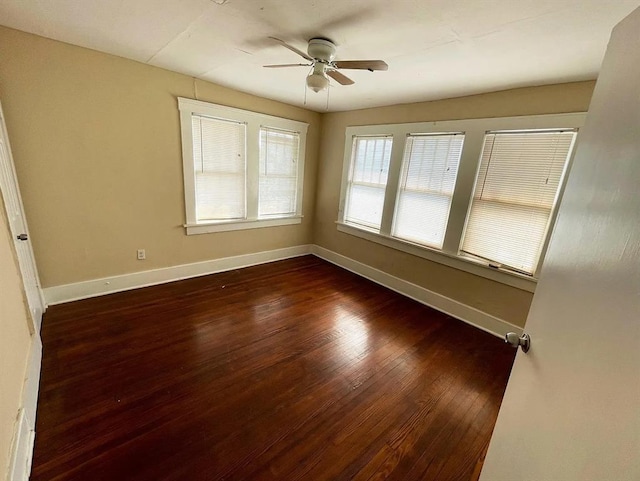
[178, 98, 307, 234]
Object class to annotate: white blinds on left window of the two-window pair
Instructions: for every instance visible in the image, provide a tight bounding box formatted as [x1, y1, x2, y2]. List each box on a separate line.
[192, 115, 246, 221]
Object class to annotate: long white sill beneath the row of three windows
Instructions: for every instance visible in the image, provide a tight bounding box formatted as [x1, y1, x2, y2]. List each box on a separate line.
[336, 222, 537, 292]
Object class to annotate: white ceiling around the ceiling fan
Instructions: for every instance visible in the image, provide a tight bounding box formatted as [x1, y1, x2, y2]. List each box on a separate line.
[0, 0, 639, 111]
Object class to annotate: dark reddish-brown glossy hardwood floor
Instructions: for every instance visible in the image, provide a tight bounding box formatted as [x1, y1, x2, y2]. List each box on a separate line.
[31, 256, 515, 481]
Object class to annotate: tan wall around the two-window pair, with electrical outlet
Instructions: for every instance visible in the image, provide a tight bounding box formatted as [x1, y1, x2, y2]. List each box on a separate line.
[0, 27, 321, 287]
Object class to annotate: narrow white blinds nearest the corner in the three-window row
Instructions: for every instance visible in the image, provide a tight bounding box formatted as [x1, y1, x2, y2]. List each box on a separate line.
[344, 136, 393, 230]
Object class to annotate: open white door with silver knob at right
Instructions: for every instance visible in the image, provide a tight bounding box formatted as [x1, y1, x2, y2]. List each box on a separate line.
[480, 9, 640, 481]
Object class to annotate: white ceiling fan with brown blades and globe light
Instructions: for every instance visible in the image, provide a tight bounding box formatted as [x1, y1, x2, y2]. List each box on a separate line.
[265, 37, 389, 92]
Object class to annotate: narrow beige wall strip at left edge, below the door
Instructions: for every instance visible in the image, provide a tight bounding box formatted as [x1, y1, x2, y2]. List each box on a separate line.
[0, 197, 31, 479]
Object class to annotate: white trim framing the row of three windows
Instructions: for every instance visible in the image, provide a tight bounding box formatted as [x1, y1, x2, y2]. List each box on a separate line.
[336, 112, 586, 292]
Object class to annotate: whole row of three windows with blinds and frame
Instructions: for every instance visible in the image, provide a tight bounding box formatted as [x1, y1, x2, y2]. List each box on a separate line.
[337, 113, 585, 292]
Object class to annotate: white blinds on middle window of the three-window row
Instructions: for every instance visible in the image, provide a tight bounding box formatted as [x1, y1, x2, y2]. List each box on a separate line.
[392, 133, 464, 249]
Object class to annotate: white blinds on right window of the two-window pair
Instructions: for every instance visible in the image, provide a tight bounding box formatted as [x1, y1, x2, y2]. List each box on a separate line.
[258, 127, 300, 217]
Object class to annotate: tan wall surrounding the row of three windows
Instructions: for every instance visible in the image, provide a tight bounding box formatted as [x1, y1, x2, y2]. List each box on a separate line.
[314, 82, 595, 326]
